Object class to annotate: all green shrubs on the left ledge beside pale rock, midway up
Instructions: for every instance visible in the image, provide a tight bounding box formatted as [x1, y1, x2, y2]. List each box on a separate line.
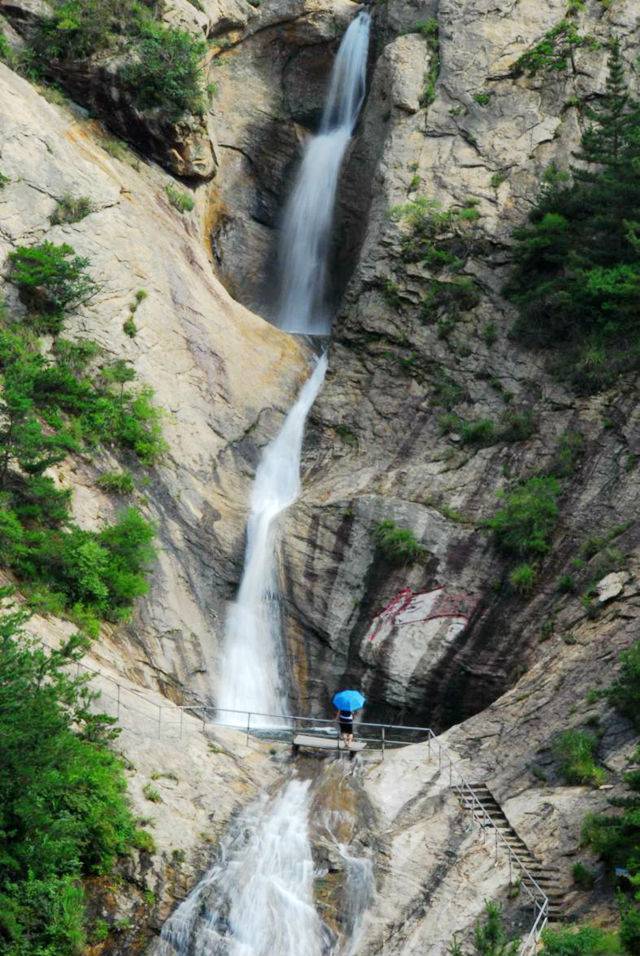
[0, 242, 164, 633]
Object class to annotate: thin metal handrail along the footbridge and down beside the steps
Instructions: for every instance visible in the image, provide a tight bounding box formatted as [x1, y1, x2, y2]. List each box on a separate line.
[41, 641, 549, 956]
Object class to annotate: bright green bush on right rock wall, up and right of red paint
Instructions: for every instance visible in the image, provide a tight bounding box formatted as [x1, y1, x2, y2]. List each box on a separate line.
[486, 477, 560, 558]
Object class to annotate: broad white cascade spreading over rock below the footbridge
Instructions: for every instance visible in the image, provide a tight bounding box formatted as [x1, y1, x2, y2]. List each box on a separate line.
[155, 780, 326, 956]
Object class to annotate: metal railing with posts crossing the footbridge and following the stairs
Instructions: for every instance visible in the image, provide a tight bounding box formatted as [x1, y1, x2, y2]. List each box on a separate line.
[43, 642, 549, 956]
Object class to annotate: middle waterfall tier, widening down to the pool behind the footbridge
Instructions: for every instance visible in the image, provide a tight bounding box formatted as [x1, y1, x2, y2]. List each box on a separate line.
[218, 355, 327, 727]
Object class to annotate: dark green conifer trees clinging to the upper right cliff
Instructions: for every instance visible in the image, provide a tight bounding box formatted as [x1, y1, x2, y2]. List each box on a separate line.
[506, 41, 640, 393]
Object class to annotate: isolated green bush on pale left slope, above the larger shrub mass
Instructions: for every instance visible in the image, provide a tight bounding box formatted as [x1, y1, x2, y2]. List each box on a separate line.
[9, 242, 99, 334]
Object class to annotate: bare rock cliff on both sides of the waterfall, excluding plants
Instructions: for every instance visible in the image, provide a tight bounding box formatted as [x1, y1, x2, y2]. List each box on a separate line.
[0, 0, 640, 954]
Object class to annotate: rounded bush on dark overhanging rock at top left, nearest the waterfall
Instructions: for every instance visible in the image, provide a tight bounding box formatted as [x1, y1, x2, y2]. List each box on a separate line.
[119, 21, 207, 121]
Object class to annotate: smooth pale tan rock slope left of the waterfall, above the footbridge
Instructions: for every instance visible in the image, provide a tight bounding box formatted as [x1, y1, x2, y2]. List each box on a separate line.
[0, 65, 307, 700]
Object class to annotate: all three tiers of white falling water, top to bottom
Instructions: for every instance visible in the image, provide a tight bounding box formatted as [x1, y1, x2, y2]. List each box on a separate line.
[154, 12, 373, 956]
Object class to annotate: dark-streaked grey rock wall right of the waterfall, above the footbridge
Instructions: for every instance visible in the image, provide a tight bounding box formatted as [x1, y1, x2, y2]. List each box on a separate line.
[278, 0, 639, 727]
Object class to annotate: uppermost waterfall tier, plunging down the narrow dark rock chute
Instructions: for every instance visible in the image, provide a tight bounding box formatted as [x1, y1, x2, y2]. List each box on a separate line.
[276, 11, 371, 335]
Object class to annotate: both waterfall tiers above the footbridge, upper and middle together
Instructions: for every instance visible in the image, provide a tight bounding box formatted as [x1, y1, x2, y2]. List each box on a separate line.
[217, 12, 370, 727]
